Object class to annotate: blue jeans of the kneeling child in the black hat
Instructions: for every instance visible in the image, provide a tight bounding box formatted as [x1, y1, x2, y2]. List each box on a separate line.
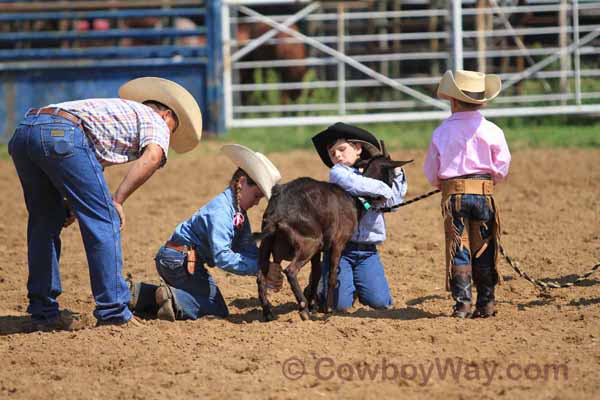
[318, 244, 393, 311]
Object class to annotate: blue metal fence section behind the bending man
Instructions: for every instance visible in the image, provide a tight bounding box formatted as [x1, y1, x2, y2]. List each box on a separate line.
[0, 0, 224, 142]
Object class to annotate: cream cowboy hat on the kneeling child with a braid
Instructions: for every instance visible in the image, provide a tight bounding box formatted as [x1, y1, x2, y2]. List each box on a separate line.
[221, 144, 281, 199]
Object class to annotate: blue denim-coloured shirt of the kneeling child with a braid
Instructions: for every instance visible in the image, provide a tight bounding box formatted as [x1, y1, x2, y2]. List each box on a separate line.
[169, 188, 258, 275]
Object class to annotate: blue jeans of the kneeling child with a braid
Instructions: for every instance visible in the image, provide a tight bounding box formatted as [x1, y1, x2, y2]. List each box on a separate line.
[154, 246, 229, 319]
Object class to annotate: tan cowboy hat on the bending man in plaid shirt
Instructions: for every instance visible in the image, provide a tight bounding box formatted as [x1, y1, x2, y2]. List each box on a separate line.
[119, 77, 202, 153]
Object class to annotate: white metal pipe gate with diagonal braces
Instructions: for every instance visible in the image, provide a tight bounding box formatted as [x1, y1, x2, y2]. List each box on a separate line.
[222, 0, 600, 127]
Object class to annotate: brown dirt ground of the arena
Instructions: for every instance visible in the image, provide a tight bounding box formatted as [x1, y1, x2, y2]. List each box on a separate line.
[0, 145, 600, 400]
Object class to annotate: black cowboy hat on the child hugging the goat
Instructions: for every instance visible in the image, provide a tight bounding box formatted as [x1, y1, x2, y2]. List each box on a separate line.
[312, 122, 381, 168]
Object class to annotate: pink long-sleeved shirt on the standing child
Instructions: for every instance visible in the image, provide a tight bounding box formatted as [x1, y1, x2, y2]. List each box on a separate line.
[423, 111, 510, 187]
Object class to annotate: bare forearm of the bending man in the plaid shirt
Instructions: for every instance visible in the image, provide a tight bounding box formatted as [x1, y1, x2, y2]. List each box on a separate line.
[113, 143, 163, 229]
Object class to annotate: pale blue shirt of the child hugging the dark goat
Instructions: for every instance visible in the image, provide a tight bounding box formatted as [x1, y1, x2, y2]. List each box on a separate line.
[329, 164, 408, 244]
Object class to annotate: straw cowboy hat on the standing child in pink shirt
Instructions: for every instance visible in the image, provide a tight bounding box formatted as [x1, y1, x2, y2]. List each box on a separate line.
[438, 70, 502, 104]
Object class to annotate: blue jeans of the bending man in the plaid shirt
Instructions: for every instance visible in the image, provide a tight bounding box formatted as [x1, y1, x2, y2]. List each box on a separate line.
[8, 111, 132, 323]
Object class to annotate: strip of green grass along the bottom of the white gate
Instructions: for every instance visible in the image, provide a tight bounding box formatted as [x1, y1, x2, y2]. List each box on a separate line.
[0, 116, 600, 160]
